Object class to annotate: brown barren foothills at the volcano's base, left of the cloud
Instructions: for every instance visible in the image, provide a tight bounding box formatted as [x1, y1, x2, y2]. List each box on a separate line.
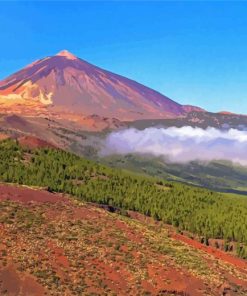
[0, 114, 127, 151]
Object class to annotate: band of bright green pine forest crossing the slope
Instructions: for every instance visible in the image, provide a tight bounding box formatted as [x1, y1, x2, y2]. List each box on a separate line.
[0, 140, 247, 254]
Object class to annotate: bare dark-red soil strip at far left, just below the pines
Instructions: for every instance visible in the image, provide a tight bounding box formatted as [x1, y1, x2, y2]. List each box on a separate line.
[0, 184, 66, 203]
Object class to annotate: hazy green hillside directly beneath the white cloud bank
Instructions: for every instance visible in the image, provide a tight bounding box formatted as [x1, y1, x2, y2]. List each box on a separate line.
[103, 154, 247, 195]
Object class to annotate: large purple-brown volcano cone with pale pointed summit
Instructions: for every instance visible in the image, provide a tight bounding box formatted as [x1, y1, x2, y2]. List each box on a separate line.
[0, 51, 202, 120]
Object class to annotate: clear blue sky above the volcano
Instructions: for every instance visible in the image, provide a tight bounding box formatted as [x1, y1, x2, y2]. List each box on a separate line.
[0, 1, 247, 114]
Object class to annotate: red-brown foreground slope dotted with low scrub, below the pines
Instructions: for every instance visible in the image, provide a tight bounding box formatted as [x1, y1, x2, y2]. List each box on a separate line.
[0, 184, 247, 296]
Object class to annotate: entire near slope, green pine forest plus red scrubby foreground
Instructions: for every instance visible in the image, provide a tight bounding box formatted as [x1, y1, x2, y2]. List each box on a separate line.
[0, 139, 247, 296]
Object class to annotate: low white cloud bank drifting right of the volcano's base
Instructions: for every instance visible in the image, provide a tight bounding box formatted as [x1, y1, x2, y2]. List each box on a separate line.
[101, 126, 247, 165]
